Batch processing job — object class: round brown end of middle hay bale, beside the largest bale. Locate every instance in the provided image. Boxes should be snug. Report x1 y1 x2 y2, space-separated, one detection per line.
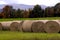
31 21 44 33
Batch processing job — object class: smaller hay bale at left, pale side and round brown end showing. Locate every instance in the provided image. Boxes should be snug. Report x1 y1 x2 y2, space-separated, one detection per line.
0 21 22 31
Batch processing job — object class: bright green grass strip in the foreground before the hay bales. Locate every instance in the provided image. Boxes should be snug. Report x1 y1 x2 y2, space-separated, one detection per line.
0 31 60 40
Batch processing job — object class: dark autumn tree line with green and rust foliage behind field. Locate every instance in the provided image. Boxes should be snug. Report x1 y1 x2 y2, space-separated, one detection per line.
0 3 60 18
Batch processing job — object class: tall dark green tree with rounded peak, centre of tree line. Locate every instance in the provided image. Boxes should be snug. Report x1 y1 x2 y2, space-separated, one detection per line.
29 5 43 18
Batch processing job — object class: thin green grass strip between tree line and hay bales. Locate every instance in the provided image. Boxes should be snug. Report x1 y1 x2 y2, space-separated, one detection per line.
0 17 60 21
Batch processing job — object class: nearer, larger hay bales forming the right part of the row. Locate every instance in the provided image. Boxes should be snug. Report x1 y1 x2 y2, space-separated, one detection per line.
22 20 60 33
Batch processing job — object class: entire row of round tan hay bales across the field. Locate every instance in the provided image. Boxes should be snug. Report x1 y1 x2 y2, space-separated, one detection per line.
0 20 60 33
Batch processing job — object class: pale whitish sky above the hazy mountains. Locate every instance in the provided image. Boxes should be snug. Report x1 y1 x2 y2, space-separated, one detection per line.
0 0 60 6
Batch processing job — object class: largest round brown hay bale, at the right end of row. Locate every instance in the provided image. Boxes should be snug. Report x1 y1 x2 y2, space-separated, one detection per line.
44 20 60 33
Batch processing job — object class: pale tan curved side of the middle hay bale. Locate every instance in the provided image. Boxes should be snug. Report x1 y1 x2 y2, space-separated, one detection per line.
22 20 33 32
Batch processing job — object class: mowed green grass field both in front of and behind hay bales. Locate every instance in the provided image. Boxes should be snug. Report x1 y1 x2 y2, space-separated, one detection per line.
0 17 60 40
